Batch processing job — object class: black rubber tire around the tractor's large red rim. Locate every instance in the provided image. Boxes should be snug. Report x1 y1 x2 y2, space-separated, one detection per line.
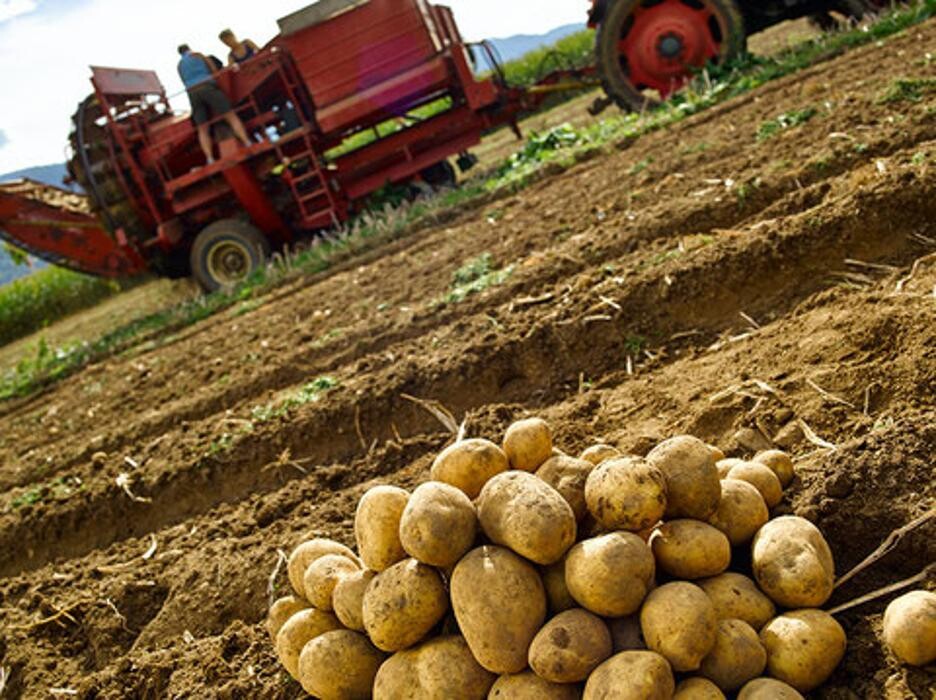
595 0 747 112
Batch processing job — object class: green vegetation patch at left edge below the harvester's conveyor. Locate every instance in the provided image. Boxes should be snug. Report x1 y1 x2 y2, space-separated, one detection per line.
0 264 121 345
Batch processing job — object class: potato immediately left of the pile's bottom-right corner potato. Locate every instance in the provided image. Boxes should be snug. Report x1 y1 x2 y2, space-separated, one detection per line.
699 620 767 690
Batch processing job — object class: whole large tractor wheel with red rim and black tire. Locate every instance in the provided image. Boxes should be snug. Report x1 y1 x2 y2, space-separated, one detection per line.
596 0 745 111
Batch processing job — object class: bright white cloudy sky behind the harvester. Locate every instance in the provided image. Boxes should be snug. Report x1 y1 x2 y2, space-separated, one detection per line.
0 0 590 173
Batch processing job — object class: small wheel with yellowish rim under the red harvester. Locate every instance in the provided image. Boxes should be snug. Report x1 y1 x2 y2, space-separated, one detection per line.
189 219 270 292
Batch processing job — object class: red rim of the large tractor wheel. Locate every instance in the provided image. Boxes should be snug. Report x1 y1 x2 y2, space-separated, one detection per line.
618 0 726 99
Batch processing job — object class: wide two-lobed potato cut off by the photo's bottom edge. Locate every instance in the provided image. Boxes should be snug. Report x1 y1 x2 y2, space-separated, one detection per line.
374 635 496 700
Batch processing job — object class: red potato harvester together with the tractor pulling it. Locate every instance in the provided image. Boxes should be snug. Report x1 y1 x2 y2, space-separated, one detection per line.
0 0 887 289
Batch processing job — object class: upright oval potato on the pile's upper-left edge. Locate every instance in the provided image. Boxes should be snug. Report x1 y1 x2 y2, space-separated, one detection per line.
354 486 409 572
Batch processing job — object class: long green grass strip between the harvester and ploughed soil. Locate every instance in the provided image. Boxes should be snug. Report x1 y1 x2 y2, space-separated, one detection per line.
0 0 936 400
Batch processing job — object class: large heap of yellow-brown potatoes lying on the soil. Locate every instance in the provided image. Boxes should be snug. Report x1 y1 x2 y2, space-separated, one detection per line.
267 418 932 700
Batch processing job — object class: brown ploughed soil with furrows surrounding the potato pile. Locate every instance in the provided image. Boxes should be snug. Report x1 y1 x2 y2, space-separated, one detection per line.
0 16 936 699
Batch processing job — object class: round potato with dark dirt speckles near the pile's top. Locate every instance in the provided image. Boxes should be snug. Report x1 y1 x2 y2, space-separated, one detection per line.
585 457 666 532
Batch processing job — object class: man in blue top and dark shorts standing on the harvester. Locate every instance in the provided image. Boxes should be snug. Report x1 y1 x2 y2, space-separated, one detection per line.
179 44 251 165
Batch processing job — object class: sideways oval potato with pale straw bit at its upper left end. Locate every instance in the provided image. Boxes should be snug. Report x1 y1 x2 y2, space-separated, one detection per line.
650 520 731 579
